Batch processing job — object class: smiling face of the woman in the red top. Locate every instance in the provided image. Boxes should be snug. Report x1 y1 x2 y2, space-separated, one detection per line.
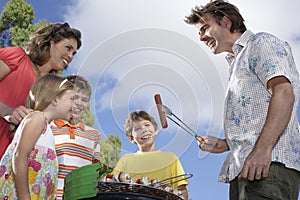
48 38 77 71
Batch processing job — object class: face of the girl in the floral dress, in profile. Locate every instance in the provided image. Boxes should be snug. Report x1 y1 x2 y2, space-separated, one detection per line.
56 90 74 121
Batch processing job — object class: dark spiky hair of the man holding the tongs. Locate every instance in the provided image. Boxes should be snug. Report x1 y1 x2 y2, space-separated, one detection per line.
184 0 247 33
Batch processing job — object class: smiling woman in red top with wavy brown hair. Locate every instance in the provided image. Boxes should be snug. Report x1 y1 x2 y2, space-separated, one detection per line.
0 23 81 158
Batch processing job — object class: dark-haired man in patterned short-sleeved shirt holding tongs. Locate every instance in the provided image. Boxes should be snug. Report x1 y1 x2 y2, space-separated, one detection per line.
185 0 300 200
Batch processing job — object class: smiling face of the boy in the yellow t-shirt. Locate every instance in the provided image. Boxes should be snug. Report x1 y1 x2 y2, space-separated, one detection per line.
132 120 157 150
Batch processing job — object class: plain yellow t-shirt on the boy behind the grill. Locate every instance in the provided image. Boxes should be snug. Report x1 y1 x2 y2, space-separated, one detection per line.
112 151 188 188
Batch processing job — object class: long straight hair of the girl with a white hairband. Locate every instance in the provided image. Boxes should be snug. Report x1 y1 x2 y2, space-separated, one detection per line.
26 74 73 111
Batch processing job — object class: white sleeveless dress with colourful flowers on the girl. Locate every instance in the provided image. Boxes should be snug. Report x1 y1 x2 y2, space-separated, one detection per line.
0 113 58 200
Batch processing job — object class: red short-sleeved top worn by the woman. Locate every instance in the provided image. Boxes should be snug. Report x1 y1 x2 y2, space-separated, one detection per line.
0 47 37 158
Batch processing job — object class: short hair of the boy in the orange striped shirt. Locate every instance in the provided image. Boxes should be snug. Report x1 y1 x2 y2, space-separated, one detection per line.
65 75 92 98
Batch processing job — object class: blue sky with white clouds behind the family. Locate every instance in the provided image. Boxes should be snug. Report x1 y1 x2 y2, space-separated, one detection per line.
0 0 300 200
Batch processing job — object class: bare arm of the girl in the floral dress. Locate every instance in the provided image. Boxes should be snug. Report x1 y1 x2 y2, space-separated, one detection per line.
13 112 45 200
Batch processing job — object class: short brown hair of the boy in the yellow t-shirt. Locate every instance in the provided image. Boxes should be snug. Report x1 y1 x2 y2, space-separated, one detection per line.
124 110 157 136
